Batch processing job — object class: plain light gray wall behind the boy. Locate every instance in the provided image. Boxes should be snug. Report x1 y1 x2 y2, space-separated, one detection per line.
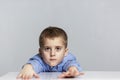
0 0 120 75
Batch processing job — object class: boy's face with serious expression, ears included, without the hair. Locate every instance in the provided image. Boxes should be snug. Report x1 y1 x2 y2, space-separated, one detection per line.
40 37 68 66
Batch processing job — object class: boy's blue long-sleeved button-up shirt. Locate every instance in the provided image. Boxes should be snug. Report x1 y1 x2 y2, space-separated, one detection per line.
27 53 82 73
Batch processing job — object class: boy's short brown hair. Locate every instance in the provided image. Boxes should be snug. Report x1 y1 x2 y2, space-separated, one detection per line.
39 26 68 48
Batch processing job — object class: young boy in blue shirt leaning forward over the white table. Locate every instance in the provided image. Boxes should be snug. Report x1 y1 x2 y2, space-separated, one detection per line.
17 26 82 79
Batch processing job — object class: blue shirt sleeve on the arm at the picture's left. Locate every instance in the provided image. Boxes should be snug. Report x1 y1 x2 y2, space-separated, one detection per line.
27 54 43 73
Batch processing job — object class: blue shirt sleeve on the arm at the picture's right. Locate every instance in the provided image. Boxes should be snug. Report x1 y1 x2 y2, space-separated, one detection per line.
63 54 82 71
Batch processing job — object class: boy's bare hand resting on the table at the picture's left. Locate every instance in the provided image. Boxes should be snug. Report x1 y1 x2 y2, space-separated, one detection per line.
17 64 39 80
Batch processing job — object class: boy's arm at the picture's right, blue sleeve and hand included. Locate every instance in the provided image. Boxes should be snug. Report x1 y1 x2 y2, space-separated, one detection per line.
59 56 83 78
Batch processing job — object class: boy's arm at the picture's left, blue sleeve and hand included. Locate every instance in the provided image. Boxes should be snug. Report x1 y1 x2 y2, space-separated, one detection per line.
17 54 43 79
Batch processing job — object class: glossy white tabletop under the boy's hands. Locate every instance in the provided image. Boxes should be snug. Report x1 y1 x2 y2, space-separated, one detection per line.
0 71 120 80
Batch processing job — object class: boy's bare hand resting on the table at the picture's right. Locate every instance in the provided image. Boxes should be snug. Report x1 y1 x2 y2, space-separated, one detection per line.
58 66 84 78
